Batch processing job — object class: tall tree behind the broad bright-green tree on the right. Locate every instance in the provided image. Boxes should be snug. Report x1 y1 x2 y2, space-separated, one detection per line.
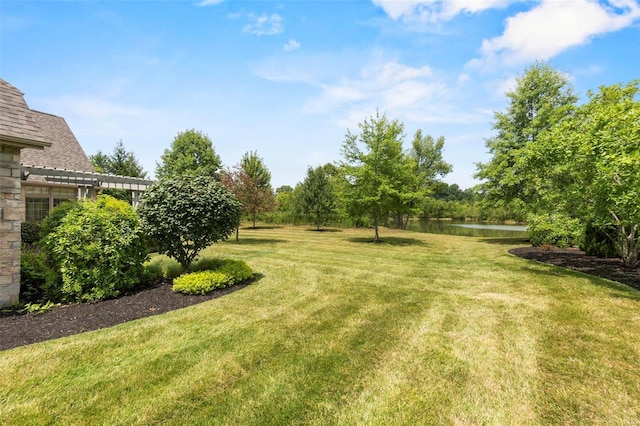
476 62 577 208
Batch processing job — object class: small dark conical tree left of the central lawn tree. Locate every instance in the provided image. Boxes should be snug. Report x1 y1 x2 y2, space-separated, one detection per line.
298 166 336 230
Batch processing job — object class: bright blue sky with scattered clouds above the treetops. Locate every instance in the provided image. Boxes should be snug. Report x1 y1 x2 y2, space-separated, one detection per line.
0 0 640 188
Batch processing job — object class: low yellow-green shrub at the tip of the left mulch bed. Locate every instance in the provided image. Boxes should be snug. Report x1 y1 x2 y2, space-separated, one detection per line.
173 259 253 294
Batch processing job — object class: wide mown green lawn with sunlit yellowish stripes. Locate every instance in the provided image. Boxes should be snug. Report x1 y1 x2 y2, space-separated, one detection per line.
0 228 640 425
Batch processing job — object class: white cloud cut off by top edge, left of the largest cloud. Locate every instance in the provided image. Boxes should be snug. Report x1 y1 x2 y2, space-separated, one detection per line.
372 0 525 23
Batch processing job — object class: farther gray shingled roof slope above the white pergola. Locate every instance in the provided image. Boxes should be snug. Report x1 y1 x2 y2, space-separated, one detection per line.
20 111 95 172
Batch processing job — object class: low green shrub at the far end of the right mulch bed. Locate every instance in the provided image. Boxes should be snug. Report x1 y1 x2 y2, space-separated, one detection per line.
527 215 584 247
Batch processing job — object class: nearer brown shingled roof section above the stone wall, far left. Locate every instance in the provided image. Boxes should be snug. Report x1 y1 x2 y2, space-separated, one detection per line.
0 78 47 146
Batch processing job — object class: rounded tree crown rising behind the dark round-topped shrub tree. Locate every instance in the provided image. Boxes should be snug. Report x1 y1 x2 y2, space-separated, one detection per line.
156 130 221 179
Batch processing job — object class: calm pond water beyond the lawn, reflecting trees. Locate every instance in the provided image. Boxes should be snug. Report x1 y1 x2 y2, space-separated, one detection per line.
407 220 527 238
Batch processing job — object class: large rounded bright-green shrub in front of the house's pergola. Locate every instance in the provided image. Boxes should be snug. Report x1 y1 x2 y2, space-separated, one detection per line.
44 195 146 300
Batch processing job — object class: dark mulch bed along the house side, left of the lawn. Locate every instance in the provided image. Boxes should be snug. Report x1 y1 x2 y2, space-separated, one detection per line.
0 282 249 351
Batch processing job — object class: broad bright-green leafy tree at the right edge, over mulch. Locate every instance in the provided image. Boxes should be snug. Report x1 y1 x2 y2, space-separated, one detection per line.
517 80 640 265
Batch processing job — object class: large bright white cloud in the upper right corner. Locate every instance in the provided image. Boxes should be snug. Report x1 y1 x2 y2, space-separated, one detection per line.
467 0 640 68
